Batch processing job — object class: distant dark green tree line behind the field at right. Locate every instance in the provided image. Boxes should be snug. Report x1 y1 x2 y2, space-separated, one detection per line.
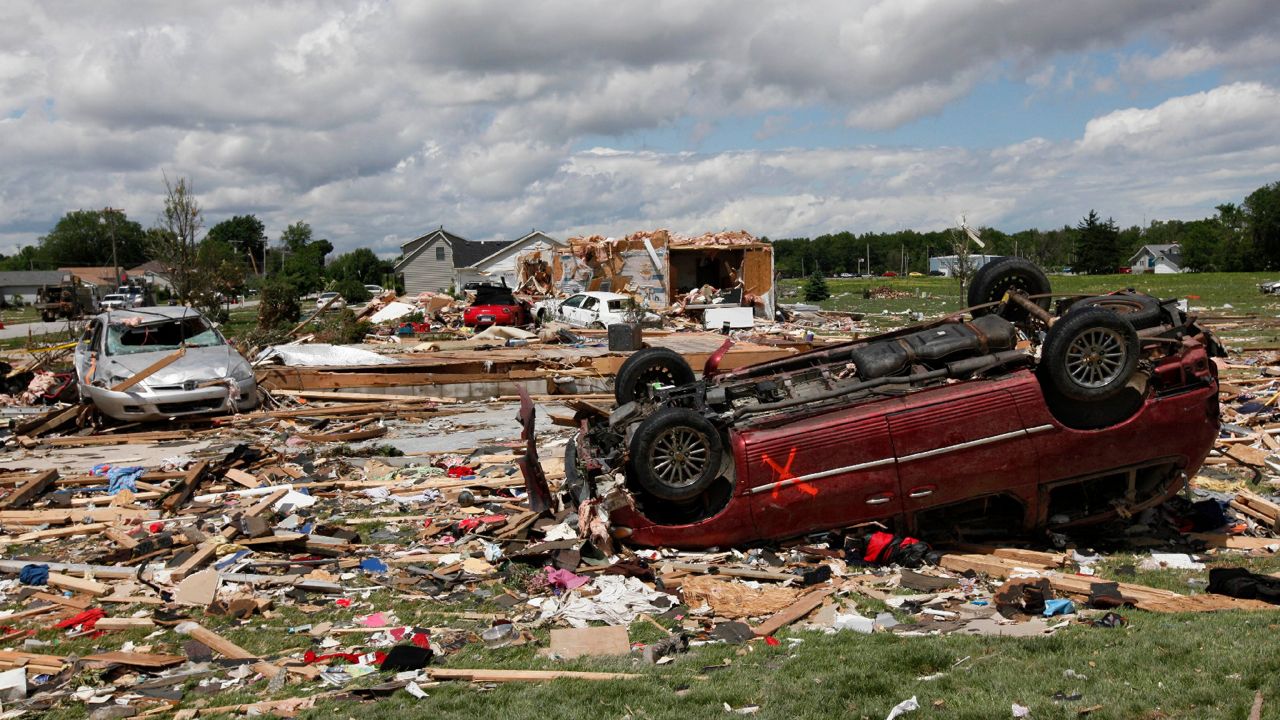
773 182 1280 278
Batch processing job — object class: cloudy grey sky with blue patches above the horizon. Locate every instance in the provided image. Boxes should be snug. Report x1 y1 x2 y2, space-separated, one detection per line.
0 0 1280 255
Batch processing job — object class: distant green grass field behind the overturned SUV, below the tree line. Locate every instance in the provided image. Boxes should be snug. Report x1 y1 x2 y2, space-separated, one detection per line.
782 273 1280 343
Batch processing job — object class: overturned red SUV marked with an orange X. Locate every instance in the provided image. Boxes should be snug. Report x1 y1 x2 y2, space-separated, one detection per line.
521 258 1221 548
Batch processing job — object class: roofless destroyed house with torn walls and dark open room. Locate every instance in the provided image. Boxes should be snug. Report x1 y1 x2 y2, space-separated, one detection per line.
517 229 774 318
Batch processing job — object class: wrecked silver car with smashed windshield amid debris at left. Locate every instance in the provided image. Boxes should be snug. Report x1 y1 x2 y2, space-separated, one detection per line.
76 307 259 420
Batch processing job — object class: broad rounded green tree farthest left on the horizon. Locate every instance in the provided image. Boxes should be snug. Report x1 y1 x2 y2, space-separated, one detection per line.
38 210 147 268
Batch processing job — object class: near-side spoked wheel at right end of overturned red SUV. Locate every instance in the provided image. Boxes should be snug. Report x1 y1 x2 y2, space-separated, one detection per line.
1041 307 1139 402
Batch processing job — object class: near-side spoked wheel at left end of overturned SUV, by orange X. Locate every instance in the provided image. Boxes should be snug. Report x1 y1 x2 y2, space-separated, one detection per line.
630 407 723 501
